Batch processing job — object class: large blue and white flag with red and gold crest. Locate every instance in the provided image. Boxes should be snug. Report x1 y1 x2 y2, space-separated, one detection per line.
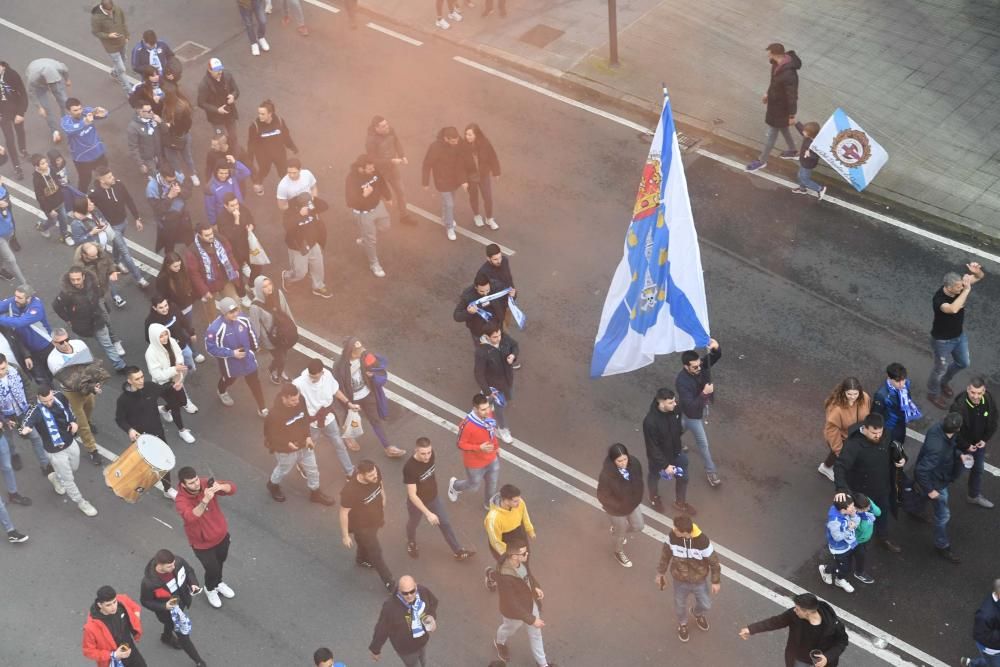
590 90 709 377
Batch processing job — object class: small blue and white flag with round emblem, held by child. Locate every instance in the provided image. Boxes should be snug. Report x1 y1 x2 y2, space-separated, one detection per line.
810 109 889 192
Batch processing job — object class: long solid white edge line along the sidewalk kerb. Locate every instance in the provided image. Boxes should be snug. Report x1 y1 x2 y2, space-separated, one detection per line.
453 56 1000 264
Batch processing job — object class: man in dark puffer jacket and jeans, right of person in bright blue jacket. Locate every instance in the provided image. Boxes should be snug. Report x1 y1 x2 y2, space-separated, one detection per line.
52 266 125 373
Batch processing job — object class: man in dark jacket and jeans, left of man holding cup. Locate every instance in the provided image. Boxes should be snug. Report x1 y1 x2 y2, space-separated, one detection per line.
916 412 972 565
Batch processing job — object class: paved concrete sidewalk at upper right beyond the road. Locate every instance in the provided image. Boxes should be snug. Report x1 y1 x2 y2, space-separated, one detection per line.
362 0 1000 239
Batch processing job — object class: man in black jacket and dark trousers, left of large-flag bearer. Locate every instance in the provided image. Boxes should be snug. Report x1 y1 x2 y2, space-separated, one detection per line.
642 387 697 516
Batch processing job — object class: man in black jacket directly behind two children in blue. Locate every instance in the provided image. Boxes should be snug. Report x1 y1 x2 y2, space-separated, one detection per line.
833 413 906 554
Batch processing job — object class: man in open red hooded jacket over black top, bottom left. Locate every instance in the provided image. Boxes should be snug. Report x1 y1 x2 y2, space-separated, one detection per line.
83 586 146 667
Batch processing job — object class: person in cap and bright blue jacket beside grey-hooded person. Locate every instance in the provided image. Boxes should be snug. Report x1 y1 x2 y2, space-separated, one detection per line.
205 296 268 417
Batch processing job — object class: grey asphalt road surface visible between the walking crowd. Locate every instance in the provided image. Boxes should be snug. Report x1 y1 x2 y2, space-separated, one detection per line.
0 0 1000 667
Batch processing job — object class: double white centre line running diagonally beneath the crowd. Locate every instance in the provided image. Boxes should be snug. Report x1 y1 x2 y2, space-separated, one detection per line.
8 189 947 667
